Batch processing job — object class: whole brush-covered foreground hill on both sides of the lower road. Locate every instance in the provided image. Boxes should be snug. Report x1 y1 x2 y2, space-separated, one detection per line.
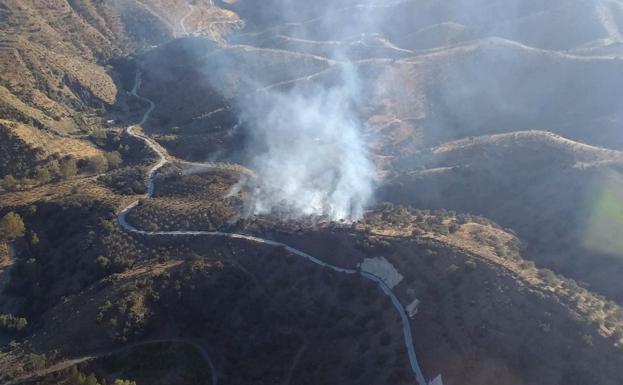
0 201 621 385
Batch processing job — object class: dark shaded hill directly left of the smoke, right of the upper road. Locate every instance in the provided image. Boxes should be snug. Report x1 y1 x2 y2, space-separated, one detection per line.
138 38 333 161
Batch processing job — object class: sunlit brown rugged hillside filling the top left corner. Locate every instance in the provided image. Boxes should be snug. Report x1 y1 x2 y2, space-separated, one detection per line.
0 0 237 177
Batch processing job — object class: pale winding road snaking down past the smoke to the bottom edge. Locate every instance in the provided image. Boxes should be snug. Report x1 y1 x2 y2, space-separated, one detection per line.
118 74 427 385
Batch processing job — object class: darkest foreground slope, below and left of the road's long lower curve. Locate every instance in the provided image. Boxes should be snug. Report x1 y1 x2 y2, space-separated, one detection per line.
2 239 410 384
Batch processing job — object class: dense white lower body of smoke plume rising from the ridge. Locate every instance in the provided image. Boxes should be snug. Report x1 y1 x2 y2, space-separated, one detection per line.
240 66 375 220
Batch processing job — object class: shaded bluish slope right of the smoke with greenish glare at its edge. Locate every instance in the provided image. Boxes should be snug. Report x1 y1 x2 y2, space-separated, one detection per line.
381 132 623 302
